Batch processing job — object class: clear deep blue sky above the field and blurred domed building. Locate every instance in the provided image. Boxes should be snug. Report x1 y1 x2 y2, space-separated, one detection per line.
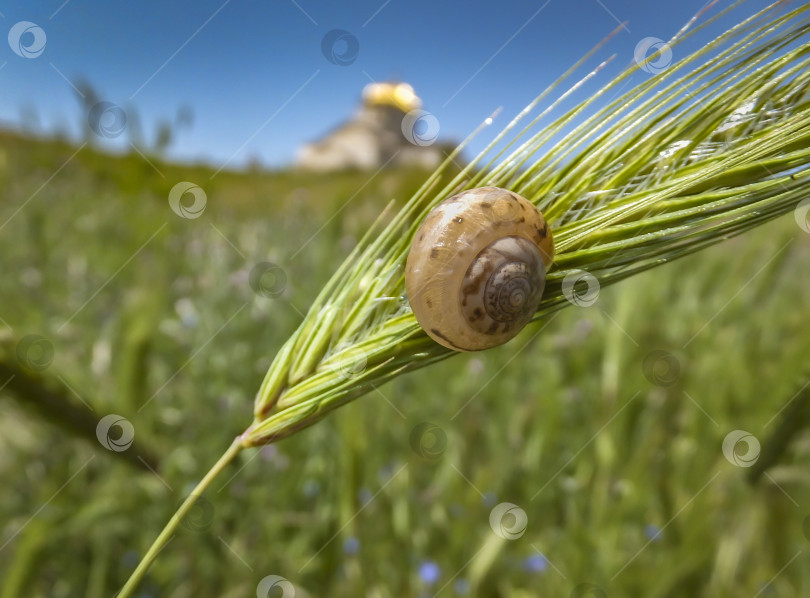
0 0 766 167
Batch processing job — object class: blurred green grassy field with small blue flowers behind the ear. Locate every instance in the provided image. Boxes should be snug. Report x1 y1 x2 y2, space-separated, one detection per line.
0 133 810 598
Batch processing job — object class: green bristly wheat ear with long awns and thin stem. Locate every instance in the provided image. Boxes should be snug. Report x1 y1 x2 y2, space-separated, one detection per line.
119 2 810 598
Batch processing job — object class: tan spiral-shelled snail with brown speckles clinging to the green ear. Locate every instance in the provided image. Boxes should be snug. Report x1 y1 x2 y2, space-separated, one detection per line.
405 187 554 351
